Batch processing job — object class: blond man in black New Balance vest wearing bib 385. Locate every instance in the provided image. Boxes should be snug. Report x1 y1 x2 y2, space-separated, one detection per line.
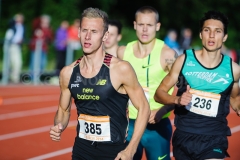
50 8 150 160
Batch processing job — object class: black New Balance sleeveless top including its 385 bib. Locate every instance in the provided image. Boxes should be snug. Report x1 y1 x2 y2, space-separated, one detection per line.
68 53 129 144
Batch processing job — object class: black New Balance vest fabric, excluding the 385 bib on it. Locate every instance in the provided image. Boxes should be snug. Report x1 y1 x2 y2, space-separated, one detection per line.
68 54 129 144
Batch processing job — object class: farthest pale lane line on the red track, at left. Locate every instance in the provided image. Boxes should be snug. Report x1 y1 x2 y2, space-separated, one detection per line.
1 94 59 105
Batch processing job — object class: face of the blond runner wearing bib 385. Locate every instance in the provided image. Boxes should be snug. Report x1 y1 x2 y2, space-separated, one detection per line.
79 17 107 54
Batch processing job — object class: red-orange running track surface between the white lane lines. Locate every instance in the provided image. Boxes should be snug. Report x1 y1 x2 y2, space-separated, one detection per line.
0 86 240 160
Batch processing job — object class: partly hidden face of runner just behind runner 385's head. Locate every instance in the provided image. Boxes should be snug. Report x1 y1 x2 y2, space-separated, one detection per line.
104 25 120 48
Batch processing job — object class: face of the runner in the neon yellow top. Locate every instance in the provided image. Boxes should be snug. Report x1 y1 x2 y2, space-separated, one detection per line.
134 13 160 43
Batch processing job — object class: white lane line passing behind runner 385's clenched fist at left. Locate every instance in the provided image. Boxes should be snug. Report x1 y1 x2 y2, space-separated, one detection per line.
0 121 77 141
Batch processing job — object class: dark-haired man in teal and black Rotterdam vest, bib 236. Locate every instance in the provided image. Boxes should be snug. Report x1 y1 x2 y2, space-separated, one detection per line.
155 11 240 160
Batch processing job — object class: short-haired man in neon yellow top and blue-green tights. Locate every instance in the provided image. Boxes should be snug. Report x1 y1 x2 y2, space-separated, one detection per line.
118 6 177 160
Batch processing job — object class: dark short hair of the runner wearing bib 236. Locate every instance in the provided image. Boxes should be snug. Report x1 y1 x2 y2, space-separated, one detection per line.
199 10 229 34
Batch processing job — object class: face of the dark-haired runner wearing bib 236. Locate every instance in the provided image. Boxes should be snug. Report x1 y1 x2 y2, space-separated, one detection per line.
200 19 227 52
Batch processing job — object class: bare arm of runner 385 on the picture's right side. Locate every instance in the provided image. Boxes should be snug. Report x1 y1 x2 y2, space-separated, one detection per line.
118 61 150 156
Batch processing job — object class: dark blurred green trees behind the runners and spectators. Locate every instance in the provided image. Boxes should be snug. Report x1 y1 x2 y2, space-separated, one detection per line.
0 0 240 70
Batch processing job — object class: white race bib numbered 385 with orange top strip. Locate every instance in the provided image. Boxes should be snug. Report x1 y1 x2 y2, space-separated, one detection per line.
78 114 111 142
